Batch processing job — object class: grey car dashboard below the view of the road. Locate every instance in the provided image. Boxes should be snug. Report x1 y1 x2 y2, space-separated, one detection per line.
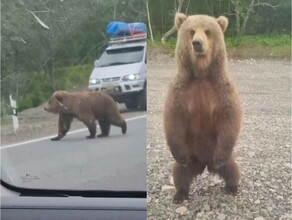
1 167 147 220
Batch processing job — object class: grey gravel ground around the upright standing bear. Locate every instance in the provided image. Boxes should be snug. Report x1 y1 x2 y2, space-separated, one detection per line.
147 54 292 220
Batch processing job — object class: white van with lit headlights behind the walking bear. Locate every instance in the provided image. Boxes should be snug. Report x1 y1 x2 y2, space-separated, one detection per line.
88 34 147 110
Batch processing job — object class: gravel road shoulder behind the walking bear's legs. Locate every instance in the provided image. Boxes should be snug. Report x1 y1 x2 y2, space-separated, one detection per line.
1 103 146 146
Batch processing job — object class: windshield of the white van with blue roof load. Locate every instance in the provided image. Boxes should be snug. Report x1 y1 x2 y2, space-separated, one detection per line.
97 46 144 67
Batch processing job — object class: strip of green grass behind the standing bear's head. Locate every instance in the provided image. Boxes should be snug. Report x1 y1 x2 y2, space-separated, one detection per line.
148 34 291 60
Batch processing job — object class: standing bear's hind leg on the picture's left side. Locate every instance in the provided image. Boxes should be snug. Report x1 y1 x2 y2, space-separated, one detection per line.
172 156 205 203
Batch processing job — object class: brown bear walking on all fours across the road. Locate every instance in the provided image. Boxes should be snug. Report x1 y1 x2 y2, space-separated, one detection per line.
44 91 127 141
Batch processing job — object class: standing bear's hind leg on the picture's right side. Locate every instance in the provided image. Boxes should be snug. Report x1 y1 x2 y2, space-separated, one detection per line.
208 158 240 195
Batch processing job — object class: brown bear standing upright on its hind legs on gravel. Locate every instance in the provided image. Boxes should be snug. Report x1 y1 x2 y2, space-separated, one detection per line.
164 13 242 203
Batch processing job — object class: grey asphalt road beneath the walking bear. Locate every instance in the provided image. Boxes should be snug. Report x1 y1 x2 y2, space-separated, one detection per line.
1 116 147 190
